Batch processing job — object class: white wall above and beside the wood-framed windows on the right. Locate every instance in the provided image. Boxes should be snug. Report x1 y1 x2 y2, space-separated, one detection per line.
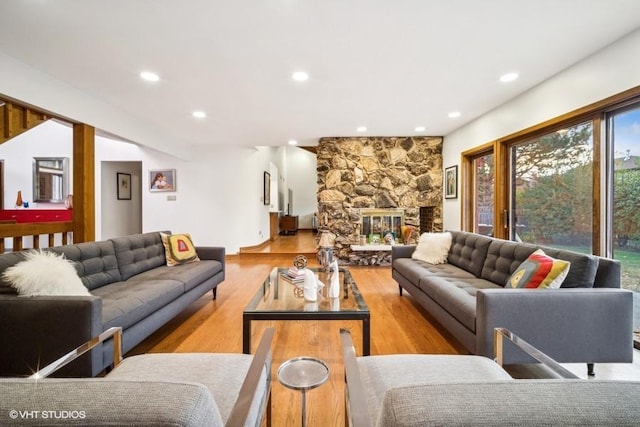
442 31 640 230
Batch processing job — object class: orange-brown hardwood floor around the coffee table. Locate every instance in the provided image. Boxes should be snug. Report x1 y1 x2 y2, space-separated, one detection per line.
127 231 640 427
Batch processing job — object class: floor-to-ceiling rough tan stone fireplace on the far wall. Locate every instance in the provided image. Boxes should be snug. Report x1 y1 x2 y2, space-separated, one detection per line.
317 137 442 265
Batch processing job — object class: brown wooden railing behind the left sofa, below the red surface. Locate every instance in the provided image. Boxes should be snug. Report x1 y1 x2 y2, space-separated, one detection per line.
0 221 73 253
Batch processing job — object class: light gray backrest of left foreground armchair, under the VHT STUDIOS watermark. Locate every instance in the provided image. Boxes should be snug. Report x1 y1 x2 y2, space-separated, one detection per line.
0 378 224 427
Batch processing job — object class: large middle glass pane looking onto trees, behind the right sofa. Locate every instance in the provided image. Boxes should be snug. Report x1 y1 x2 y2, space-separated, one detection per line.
509 122 593 254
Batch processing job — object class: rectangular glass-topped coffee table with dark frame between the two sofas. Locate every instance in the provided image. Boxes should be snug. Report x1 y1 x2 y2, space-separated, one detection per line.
242 267 371 356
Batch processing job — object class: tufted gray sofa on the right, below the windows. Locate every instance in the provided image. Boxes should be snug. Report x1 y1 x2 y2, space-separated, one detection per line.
391 231 633 369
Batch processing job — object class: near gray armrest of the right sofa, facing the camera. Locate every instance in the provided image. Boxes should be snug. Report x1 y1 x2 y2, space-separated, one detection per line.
475 288 633 363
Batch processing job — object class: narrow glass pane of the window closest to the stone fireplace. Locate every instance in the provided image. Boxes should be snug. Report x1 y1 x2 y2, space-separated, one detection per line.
472 153 495 236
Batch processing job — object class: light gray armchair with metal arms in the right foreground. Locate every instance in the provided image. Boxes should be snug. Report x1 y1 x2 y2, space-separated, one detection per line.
340 330 640 427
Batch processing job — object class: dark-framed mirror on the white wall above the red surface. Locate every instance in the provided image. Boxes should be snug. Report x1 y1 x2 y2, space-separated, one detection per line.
33 157 69 203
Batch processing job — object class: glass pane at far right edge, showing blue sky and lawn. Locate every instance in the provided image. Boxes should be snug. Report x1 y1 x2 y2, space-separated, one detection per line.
607 103 640 341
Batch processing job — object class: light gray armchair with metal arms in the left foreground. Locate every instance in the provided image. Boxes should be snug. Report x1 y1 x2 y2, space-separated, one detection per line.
0 328 274 427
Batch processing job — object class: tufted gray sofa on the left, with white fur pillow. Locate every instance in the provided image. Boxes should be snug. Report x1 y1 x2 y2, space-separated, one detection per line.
0 232 225 376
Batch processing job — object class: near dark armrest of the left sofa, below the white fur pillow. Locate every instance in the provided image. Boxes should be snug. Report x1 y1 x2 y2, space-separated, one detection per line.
0 295 103 377
